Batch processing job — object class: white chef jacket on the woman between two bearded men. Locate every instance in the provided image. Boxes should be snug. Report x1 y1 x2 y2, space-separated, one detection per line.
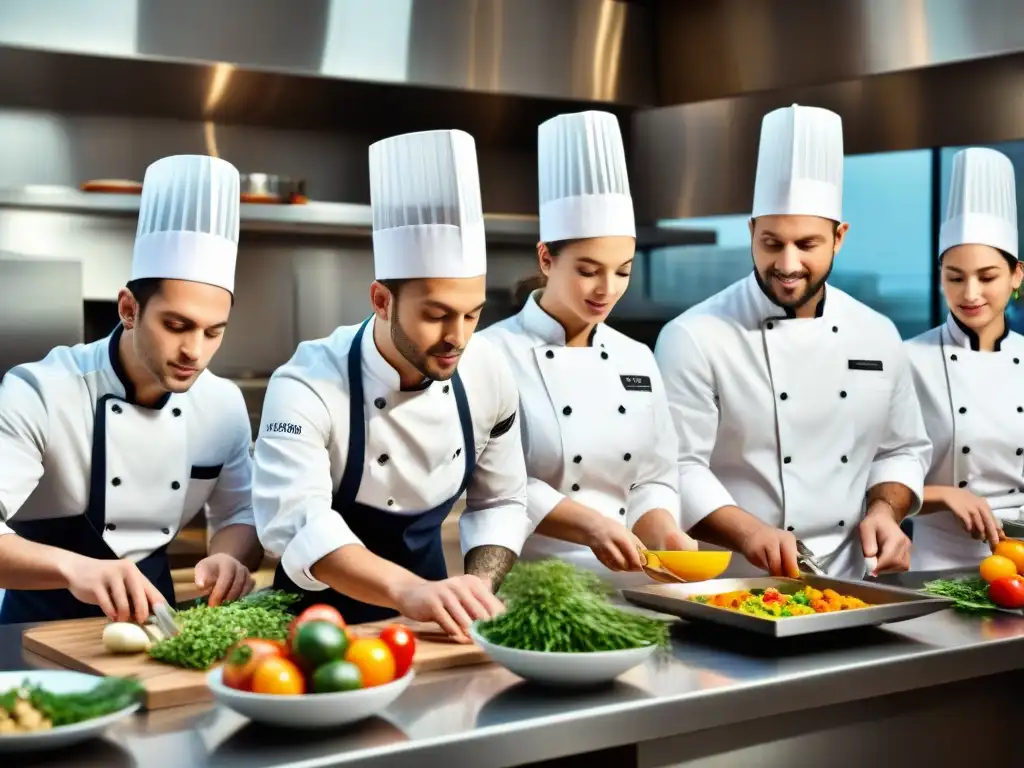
480 294 679 587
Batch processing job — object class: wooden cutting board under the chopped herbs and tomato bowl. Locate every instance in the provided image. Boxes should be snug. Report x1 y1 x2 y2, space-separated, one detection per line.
22 618 488 710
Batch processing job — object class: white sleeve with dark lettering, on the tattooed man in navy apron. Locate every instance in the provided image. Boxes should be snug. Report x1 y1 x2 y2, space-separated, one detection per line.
253 375 360 591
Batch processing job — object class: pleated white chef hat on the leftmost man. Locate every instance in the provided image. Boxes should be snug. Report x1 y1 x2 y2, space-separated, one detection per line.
131 155 241 293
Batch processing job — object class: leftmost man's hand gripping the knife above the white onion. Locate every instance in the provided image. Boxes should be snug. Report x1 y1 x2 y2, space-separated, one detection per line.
68 557 167 624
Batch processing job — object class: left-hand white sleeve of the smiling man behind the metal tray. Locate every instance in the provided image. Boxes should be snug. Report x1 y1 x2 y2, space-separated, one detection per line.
654 323 736 530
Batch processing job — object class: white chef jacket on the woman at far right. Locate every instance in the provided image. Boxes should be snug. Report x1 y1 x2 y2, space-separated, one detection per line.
906 313 1024 570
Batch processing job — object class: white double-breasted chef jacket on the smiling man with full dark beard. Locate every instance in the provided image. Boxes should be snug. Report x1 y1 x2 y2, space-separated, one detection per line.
654 273 931 579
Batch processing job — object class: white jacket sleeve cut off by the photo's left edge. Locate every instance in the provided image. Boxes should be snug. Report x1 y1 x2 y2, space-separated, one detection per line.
0 369 49 536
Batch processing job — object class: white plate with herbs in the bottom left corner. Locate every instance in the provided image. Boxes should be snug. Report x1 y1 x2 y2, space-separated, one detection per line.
0 670 141 753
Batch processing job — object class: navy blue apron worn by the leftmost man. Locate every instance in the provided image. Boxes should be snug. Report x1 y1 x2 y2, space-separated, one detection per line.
0 326 175 625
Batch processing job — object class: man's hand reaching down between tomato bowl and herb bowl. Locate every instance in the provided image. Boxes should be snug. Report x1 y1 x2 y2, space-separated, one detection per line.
395 573 505 643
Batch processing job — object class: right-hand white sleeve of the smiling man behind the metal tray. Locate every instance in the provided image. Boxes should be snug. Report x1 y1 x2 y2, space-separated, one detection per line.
867 347 933 515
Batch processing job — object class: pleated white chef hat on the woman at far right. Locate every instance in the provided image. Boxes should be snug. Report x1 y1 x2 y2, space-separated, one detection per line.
939 146 1018 259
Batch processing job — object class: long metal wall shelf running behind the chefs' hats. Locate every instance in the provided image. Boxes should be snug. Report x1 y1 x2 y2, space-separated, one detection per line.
0 185 715 248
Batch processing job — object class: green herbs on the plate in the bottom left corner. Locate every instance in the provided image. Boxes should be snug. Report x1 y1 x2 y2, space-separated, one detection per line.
0 677 145 728
